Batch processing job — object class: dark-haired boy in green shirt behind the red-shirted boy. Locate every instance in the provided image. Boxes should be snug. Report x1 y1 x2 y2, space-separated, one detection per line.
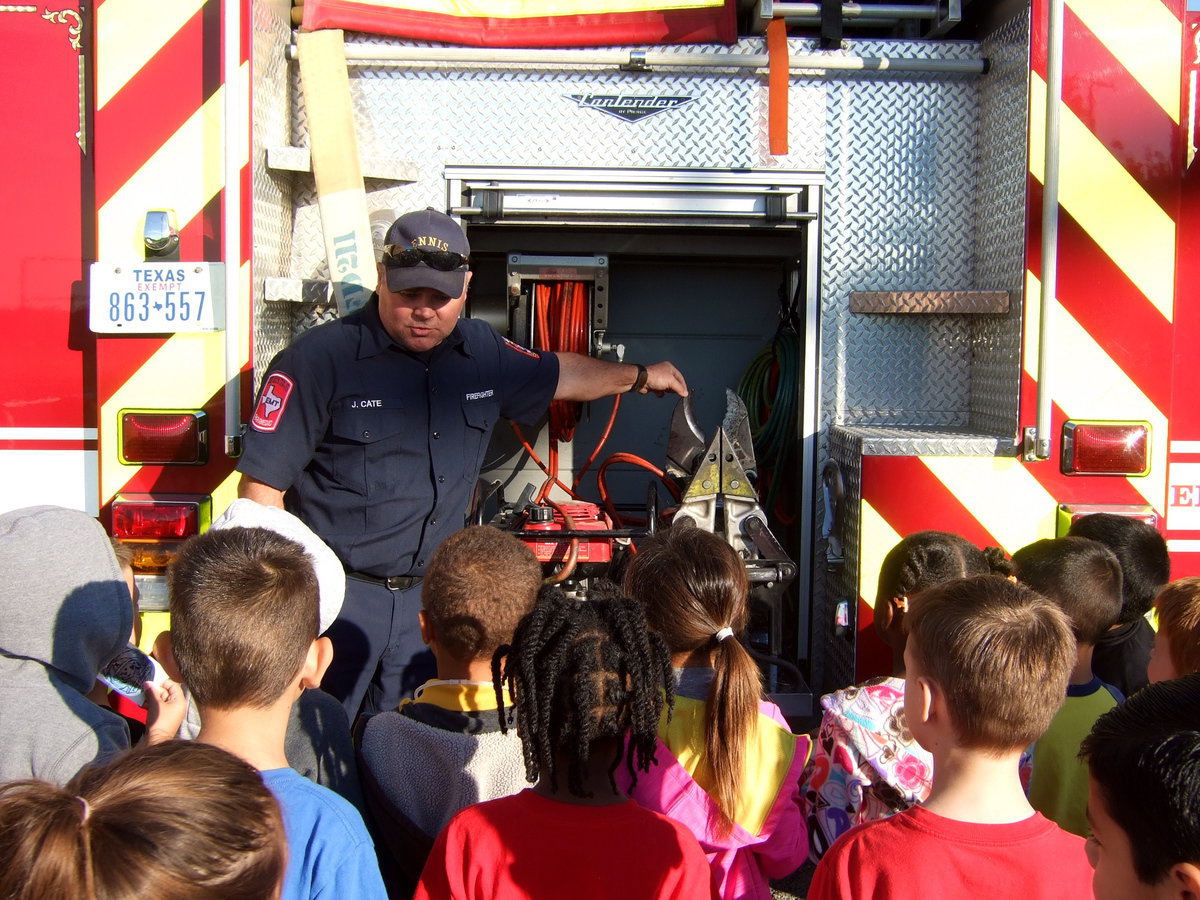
1013 536 1124 836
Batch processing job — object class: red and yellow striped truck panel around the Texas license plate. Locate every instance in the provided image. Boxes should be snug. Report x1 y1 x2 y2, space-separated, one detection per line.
95 0 251 525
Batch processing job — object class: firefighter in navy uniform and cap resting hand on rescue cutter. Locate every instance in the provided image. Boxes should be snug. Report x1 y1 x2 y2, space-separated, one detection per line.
238 209 688 720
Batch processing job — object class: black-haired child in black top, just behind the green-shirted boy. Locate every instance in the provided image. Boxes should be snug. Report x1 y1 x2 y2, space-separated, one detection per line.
1068 512 1171 697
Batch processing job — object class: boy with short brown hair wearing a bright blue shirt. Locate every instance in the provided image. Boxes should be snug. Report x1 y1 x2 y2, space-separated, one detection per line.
168 528 385 900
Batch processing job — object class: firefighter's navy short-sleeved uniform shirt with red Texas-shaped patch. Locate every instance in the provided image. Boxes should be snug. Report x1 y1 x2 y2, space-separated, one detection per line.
238 296 558 577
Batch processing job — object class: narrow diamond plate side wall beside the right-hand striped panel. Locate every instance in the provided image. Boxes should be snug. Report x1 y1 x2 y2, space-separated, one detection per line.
970 10 1030 436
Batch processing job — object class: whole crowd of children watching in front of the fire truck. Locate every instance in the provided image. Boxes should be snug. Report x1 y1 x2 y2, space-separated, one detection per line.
0 500 1200 900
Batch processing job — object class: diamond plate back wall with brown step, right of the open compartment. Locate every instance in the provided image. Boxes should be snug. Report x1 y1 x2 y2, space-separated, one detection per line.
821 42 979 434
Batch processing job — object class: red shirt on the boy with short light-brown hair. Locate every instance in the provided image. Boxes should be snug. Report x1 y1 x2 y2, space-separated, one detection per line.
808 806 1092 900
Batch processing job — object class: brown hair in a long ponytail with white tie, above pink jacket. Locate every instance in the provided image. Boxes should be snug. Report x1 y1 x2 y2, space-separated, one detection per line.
625 524 762 829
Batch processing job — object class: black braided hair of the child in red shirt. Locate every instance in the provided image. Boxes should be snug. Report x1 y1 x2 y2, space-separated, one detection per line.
492 584 674 797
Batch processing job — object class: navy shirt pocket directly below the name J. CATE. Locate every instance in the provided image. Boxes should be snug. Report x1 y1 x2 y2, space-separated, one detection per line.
329 400 404 497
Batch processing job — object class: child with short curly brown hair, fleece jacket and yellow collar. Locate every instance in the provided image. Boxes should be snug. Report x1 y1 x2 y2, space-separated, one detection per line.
360 526 542 889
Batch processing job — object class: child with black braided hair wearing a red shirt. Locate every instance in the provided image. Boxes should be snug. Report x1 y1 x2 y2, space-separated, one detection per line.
414 588 714 900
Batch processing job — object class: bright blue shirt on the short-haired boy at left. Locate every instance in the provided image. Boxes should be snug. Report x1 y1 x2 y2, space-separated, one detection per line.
263 769 388 900
